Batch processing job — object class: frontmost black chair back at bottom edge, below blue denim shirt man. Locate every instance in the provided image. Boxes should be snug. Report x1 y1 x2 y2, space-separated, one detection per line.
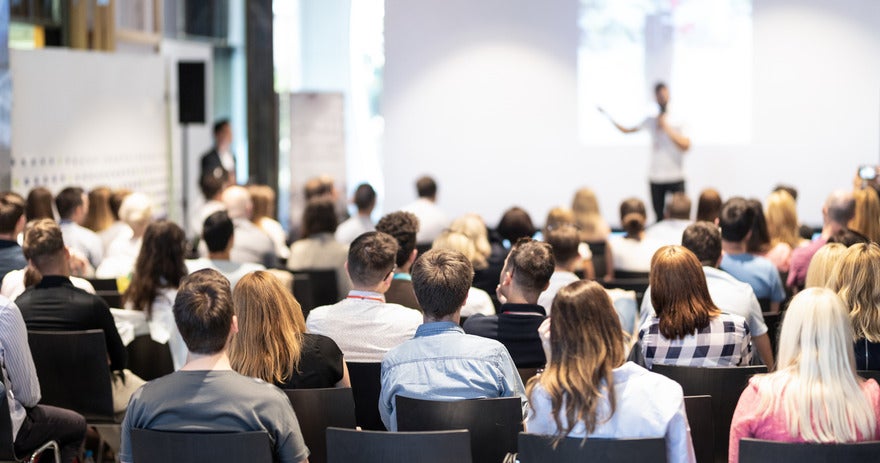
326 428 470 463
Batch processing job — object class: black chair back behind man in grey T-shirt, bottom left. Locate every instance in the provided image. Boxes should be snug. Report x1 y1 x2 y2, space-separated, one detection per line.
131 429 272 463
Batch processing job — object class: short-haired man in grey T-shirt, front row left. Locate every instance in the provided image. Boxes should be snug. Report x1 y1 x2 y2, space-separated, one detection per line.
119 269 309 463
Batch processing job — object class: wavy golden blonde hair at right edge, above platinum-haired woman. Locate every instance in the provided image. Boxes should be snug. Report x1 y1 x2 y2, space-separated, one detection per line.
827 243 880 342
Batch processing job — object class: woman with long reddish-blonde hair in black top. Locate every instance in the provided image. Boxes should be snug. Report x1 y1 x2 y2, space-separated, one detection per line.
229 270 351 389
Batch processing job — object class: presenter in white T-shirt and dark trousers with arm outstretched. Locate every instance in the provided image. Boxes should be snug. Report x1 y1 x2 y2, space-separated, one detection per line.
599 82 691 225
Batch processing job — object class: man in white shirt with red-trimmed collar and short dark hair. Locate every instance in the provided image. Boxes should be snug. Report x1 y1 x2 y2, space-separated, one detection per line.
306 232 422 363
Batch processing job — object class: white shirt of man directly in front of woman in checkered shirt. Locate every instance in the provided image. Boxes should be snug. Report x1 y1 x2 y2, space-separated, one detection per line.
641 266 767 337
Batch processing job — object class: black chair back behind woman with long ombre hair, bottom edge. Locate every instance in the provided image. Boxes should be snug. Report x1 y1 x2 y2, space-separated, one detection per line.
517 432 666 463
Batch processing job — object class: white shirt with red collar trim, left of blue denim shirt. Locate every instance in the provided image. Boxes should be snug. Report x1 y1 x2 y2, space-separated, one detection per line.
306 291 423 363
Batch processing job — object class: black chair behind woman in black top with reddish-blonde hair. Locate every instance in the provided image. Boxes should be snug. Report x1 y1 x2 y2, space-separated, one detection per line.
284 387 357 463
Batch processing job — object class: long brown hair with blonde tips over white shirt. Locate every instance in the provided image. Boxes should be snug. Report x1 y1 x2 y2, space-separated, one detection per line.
526 280 626 443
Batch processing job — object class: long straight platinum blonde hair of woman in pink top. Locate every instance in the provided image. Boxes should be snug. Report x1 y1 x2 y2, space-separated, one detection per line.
760 288 877 443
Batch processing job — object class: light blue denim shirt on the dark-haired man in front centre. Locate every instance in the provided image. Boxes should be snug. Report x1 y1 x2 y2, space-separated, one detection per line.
379 322 528 431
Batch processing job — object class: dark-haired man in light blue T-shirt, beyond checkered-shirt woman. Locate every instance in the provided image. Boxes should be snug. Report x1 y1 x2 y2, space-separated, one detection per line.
719 198 785 312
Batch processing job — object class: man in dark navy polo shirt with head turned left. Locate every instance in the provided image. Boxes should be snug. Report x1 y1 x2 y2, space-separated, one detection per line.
464 238 556 368
